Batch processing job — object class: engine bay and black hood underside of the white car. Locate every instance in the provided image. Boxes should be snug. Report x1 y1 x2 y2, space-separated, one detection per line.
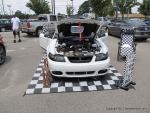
56 24 101 57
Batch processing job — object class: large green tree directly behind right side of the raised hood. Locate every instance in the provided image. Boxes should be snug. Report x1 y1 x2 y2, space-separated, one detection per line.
89 0 112 16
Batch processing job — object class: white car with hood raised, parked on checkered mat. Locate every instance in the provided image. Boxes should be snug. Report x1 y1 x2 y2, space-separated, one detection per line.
39 19 110 78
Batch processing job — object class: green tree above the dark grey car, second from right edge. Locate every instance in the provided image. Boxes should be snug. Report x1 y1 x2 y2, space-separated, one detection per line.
113 0 139 19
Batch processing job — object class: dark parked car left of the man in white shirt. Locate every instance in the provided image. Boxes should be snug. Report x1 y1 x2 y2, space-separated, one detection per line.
0 19 12 32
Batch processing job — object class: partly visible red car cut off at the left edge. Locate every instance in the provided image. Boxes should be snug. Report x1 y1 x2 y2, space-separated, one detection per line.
0 35 6 65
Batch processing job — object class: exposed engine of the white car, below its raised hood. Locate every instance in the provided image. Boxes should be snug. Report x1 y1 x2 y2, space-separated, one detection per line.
56 36 101 57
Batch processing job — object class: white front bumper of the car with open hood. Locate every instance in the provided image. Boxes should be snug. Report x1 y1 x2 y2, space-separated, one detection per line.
48 58 110 78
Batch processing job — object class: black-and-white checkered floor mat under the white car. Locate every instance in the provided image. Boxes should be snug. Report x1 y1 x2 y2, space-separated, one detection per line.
25 59 122 95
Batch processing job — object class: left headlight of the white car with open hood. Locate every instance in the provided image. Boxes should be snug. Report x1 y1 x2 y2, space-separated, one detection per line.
48 53 65 62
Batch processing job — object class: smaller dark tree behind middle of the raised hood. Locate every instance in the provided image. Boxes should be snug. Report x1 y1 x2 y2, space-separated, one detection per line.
78 1 90 15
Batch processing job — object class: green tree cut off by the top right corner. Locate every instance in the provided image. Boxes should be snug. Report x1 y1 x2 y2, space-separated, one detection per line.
138 0 150 17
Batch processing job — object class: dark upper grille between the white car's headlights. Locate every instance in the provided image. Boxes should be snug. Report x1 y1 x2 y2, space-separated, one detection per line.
68 56 93 63
